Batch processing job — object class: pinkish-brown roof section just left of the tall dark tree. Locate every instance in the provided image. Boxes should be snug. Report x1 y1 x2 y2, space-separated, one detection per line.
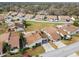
8 32 20 50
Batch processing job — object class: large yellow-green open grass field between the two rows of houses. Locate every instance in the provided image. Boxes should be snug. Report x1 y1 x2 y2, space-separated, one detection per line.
26 21 62 31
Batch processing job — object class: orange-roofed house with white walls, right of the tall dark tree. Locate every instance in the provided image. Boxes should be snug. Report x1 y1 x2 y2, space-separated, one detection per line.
24 31 47 47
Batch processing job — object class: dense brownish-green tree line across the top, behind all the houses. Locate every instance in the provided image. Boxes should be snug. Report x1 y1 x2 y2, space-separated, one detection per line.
0 2 79 16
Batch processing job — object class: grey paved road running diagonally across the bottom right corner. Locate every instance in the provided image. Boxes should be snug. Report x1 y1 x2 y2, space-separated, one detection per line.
42 42 79 57
